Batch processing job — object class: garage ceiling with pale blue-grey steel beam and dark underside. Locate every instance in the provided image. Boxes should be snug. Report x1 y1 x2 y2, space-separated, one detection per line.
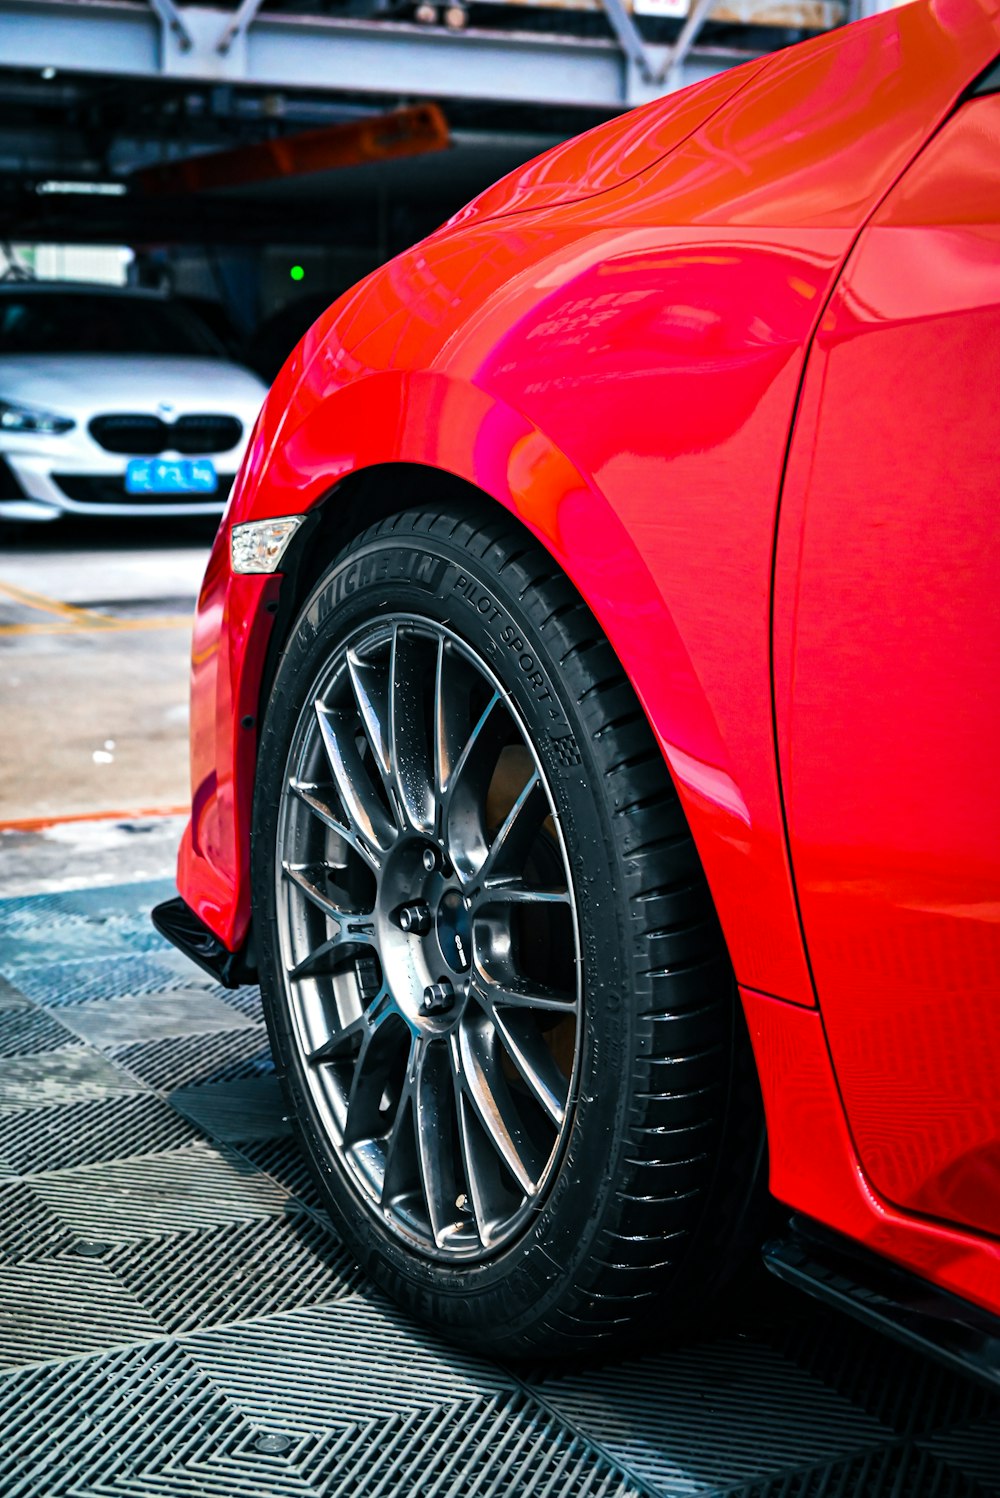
0 0 826 247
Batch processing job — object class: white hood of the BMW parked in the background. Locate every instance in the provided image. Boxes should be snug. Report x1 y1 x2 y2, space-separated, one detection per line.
0 354 268 419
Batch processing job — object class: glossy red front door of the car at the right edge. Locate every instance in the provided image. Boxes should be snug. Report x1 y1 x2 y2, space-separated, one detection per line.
774 85 1000 1233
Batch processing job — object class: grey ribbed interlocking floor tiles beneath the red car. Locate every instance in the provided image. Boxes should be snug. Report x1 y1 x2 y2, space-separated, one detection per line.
0 882 1000 1498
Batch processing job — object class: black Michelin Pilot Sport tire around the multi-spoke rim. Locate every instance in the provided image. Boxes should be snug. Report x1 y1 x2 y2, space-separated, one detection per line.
251 502 765 1356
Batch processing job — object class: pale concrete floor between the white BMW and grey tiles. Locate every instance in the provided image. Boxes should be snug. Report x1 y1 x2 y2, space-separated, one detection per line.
0 520 211 838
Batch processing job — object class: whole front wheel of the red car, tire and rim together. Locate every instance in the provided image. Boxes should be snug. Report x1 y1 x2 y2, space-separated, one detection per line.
253 506 762 1354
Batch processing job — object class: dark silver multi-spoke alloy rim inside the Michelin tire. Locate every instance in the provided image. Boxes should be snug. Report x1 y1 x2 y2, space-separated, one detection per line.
275 614 582 1261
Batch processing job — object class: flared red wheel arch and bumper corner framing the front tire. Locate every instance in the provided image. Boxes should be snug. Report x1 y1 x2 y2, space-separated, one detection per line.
178 372 810 1002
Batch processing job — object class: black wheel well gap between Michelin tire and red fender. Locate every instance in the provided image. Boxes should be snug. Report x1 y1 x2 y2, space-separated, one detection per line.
257 463 497 722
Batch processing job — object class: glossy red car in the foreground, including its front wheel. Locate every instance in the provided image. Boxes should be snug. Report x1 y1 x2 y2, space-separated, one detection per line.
156 0 1000 1378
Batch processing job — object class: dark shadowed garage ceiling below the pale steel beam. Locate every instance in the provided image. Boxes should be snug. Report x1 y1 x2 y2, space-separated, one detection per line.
0 70 577 244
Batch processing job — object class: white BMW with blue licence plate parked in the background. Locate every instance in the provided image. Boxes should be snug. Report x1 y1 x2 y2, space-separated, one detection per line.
0 282 266 521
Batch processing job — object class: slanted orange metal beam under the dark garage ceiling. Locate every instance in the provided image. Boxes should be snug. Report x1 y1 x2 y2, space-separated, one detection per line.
135 103 451 196
